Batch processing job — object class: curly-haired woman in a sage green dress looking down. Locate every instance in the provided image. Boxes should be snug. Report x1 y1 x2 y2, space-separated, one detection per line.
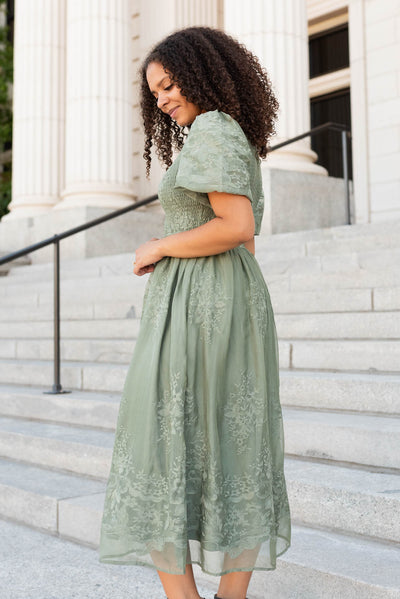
100 27 290 599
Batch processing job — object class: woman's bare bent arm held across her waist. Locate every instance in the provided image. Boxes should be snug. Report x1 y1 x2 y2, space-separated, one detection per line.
134 191 254 275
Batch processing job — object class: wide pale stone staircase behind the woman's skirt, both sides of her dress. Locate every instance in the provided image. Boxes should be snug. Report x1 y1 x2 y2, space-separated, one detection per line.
0 222 400 599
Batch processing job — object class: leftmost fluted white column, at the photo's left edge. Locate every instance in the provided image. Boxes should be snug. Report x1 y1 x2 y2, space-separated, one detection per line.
2 0 65 221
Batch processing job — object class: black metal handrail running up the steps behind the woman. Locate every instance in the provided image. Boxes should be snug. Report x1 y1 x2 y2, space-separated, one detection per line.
0 122 350 394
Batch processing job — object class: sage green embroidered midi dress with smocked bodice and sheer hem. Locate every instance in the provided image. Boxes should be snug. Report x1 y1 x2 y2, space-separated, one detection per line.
99 110 290 575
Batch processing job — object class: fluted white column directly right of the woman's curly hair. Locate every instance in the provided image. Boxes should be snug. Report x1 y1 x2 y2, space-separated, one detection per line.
224 0 326 174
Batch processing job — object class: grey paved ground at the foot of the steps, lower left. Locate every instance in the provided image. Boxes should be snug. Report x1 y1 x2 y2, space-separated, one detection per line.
0 520 214 599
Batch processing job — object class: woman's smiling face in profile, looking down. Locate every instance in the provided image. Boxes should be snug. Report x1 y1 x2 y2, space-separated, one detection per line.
146 62 205 127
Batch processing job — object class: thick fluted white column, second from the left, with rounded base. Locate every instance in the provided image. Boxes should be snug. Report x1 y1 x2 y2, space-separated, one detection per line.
57 0 134 209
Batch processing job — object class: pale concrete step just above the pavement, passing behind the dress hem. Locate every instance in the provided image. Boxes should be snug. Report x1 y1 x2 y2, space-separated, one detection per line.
0 458 400 545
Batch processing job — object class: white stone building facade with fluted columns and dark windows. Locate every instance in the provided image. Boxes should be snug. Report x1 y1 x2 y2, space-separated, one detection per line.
0 0 400 258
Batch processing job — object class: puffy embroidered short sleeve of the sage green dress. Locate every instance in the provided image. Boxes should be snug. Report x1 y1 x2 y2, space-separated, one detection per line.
175 110 254 202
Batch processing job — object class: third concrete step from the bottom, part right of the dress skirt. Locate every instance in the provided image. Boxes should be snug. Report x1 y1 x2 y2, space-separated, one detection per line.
283 408 400 470
